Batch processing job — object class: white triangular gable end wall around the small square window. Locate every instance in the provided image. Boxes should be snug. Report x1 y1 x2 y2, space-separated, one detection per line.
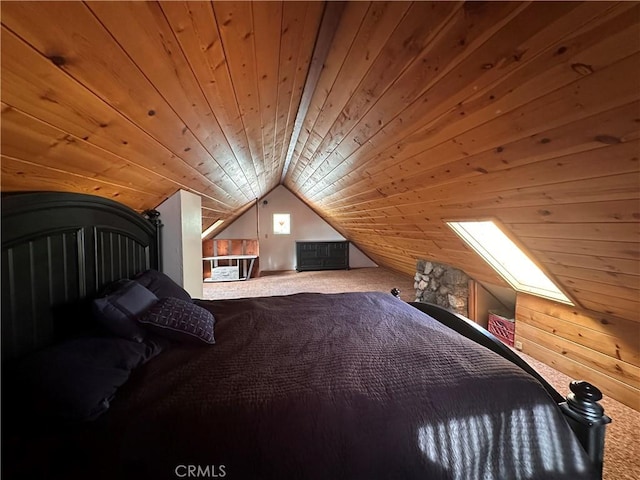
215 185 377 271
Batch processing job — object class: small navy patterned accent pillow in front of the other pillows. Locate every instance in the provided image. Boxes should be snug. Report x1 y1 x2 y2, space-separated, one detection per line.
138 297 216 345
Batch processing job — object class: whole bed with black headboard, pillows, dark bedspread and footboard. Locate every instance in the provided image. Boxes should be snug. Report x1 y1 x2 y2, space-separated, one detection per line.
2 192 609 480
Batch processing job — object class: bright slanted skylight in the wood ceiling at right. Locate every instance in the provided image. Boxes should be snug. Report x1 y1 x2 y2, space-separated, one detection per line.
447 221 573 305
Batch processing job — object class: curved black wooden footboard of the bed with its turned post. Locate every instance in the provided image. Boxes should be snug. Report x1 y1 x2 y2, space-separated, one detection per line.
402 296 611 478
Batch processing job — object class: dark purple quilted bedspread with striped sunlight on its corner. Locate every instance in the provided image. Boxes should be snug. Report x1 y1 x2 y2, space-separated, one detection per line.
13 293 594 480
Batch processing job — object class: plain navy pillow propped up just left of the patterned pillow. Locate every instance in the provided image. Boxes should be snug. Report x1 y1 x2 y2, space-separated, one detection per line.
93 280 158 342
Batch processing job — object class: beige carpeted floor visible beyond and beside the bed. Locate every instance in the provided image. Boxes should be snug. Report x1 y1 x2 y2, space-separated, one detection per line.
203 268 640 480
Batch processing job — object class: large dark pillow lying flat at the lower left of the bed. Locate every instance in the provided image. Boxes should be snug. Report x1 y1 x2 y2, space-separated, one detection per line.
9 337 163 421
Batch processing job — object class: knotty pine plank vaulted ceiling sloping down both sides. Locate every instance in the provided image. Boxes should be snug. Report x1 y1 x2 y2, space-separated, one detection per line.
1 2 640 320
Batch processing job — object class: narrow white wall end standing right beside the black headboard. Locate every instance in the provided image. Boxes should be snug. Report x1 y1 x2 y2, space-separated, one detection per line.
156 190 202 298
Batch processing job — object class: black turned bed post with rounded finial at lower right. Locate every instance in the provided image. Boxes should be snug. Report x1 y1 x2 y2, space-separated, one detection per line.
560 380 611 478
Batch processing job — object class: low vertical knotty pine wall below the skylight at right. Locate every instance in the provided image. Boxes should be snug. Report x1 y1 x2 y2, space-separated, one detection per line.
516 294 640 409
